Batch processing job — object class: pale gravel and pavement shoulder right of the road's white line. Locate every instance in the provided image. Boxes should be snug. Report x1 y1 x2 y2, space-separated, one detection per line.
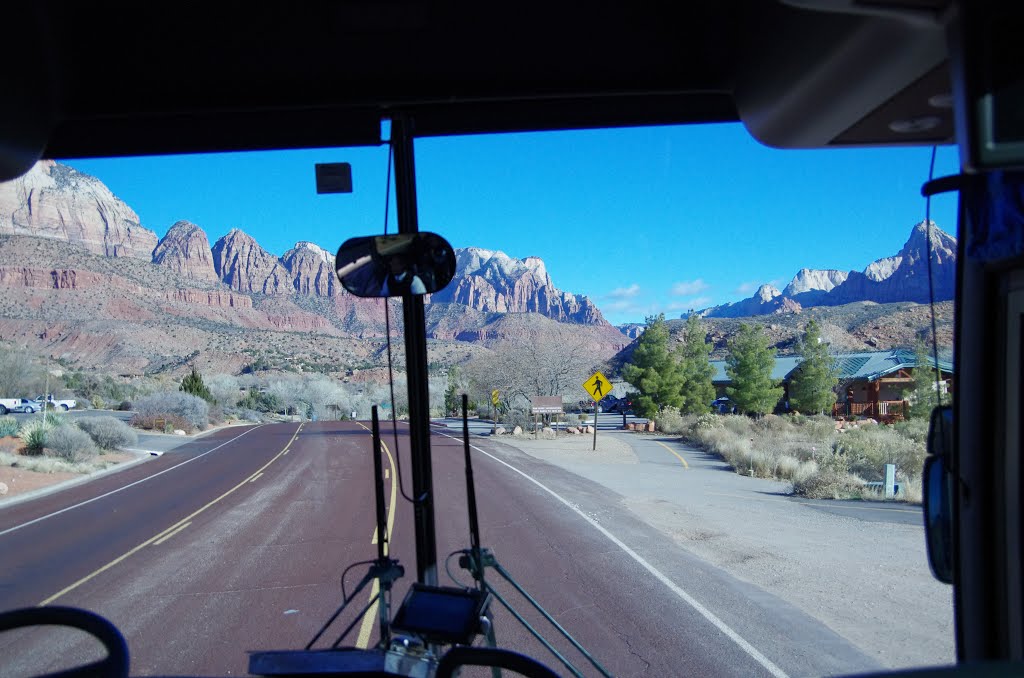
491 434 955 668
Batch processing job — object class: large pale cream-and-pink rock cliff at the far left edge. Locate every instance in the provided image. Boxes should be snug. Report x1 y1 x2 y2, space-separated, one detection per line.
0 160 157 261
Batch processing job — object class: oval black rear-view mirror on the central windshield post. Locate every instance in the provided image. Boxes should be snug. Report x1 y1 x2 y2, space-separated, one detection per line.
335 232 455 297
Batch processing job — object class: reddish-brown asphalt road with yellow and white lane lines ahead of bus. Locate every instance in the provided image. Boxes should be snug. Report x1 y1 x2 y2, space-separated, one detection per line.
0 422 878 676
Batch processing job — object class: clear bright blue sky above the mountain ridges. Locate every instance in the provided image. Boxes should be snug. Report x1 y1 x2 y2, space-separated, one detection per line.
68 124 958 324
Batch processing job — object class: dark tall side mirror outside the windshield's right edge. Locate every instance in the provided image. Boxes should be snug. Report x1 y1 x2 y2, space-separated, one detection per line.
922 406 953 584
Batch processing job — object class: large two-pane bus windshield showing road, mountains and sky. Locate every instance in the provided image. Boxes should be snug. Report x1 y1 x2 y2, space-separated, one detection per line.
0 125 957 676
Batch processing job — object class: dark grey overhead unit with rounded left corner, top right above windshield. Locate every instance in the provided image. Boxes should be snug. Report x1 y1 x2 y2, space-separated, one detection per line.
734 7 954 149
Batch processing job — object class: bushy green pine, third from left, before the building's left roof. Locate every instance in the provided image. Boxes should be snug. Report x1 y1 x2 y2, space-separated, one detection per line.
725 323 782 415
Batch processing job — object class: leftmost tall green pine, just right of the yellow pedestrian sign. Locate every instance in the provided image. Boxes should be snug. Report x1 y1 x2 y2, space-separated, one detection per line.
623 313 683 417
